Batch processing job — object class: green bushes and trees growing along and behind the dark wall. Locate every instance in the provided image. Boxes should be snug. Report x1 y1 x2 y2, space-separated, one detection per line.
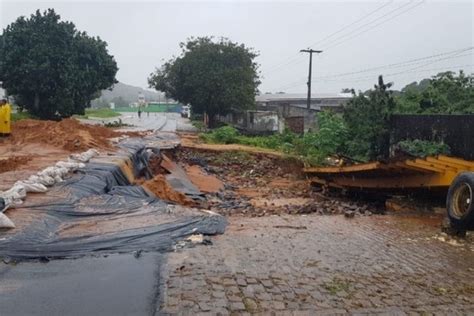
201 72 474 165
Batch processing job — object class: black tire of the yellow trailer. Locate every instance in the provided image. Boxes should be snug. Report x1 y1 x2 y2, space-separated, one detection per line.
446 172 474 230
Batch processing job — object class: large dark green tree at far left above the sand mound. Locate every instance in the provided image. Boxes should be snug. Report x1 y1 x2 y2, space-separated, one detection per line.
0 9 118 119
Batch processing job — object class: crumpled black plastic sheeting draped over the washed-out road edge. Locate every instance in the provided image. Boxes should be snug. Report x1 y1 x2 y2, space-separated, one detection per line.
0 136 227 259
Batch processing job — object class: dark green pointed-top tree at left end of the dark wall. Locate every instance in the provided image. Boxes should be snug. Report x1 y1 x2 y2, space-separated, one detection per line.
343 76 395 160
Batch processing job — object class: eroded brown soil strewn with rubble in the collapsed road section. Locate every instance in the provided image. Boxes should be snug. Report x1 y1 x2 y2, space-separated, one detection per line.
175 148 384 216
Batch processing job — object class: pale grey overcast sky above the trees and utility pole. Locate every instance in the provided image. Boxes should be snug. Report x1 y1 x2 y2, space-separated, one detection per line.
0 0 474 93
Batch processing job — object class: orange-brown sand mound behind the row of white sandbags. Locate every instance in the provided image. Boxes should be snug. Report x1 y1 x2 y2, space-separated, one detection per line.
11 119 121 151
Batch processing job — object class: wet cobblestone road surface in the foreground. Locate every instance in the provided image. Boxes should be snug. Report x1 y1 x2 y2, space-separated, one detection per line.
160 215 474 315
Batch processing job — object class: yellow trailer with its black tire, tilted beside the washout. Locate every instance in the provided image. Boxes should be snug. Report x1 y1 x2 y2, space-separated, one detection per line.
304 155 474 231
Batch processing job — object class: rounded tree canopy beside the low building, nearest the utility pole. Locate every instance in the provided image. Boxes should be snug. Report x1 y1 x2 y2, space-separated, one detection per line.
148 37 260 124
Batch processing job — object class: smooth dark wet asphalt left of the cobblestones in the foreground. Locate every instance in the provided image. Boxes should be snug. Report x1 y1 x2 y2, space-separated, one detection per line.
0 254 162 316
